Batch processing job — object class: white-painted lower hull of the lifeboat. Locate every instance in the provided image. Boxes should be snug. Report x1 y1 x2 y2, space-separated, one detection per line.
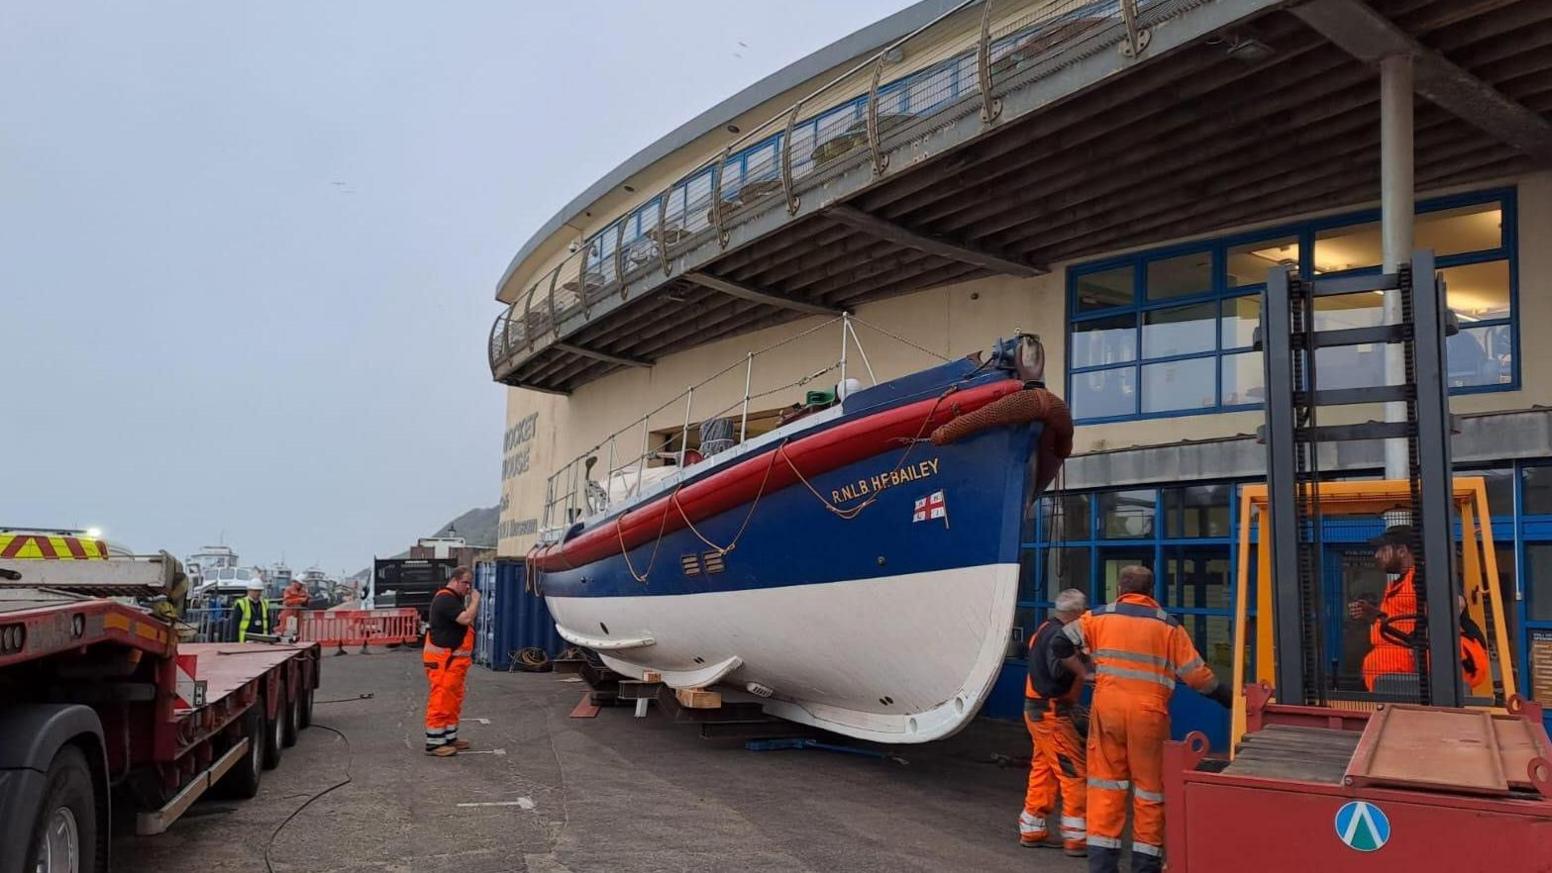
546 564 1018 743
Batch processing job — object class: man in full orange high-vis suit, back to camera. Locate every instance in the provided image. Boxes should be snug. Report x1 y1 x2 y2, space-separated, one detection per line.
1052 565 1232 873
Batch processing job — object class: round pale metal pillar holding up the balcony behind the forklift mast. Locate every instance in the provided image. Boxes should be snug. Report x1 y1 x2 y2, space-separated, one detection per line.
1380 54 1415 475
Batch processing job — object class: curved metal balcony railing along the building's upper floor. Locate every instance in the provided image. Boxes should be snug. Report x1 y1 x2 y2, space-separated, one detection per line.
489 0 1167 374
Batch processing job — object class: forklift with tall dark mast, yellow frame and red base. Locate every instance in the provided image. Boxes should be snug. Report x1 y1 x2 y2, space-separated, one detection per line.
1164 252 1552 873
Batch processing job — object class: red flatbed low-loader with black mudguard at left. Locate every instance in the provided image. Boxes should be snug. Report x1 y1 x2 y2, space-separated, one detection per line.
0 553 320 873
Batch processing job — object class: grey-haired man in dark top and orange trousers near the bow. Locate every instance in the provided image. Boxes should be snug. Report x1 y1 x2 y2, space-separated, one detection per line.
1018 589 1088 857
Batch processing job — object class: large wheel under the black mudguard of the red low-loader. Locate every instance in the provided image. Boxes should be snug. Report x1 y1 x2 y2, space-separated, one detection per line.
22 746 99 873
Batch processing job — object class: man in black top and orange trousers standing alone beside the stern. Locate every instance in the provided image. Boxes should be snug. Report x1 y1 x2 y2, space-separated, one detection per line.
421 567 480 758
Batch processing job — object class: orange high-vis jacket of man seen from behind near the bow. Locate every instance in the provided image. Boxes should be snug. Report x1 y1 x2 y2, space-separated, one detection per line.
1057 584 1218 702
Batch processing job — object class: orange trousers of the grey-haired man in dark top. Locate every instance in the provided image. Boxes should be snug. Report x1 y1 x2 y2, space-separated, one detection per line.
1018 707 1088 848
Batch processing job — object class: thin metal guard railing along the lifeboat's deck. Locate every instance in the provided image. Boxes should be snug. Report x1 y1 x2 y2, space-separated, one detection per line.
542 314 912 533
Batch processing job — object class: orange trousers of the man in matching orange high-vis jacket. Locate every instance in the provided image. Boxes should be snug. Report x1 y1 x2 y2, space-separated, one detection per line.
1088 690 1169 873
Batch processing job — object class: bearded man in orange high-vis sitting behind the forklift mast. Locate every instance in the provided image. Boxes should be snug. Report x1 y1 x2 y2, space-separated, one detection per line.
1347 525 1491 691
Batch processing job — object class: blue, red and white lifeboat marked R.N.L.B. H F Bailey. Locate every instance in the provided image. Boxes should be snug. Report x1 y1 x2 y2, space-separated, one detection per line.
529 336 1072 743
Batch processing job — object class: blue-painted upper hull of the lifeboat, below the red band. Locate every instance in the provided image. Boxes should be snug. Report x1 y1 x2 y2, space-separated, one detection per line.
543 424 1040 596
